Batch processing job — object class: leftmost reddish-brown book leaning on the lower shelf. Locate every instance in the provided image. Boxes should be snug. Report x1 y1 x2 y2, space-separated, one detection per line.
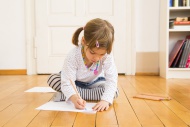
169 40 185 67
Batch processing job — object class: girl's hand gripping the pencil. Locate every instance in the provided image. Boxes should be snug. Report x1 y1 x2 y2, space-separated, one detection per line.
70 94 86 109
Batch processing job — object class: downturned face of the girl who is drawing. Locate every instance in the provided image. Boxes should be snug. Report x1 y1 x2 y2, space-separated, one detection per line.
84 45 107 63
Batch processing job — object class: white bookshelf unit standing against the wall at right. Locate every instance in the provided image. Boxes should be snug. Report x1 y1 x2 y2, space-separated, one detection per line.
160 0 190 78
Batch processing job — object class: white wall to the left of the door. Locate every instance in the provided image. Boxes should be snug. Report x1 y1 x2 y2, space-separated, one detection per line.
0 0 26 70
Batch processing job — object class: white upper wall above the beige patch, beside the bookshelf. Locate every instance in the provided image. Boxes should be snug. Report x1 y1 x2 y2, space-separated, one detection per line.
134 0 159 52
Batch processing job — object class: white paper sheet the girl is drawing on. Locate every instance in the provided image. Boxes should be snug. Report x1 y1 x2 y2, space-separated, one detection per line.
36 101 96 113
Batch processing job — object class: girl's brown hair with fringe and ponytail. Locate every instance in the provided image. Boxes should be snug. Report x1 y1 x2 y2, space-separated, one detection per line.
72 18 114 54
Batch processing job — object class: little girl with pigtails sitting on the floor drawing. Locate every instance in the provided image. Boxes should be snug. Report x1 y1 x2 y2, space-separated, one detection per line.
48 18 118 111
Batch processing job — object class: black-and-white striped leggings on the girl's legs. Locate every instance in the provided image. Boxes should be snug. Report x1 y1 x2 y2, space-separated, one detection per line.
47 73 119 101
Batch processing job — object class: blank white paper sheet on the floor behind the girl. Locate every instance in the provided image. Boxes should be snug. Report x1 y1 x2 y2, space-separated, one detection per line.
24 87 56 93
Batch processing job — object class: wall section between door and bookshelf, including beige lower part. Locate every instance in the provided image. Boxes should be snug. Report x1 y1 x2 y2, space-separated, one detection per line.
134 0 160 75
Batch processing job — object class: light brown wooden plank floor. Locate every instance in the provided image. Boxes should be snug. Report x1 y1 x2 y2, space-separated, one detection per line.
0 75 190 127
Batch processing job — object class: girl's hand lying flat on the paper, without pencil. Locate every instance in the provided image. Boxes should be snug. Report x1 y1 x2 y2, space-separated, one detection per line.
92 100 109 112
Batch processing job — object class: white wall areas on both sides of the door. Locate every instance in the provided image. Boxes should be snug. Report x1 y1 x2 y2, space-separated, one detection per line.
0 0 159 70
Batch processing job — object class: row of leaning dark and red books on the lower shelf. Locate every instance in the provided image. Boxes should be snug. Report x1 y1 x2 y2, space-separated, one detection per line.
169 35 190 68
